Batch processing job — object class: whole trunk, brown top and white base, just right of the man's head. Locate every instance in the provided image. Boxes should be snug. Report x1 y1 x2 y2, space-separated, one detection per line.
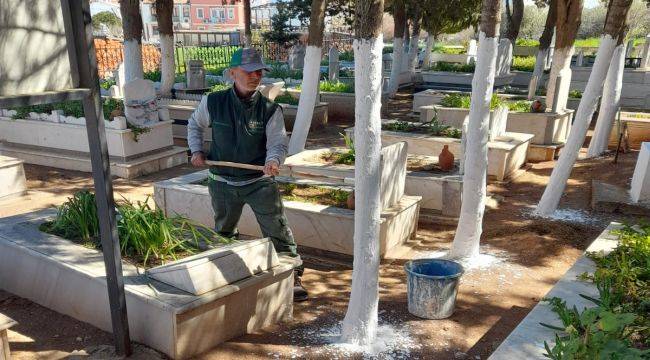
289 0 326 155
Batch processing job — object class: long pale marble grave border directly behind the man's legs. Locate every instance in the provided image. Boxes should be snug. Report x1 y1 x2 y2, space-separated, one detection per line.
154 170 420 258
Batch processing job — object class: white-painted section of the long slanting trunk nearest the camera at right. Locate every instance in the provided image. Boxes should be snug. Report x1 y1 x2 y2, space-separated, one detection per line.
536 35 616 216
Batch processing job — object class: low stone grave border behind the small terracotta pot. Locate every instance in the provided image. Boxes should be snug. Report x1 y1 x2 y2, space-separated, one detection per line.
345 127 533 181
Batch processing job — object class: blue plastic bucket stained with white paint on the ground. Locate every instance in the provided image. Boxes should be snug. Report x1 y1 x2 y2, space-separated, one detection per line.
404 259 464 319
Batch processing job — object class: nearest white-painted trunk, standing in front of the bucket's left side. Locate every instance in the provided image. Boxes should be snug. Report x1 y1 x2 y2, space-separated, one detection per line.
341 0 384 345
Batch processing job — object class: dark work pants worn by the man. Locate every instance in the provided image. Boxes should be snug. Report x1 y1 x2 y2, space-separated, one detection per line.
208 178 303 276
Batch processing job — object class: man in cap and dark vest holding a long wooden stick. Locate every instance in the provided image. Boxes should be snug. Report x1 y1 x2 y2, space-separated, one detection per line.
187 48 308 301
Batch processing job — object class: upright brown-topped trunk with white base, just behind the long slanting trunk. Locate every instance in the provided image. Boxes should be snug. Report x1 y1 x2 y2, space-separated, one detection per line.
546 0 582 110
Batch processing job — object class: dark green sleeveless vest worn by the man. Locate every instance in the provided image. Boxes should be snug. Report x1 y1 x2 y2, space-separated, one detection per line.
208 88 278 181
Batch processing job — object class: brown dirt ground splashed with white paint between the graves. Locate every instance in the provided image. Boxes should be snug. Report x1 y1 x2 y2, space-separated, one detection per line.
0 88 637 360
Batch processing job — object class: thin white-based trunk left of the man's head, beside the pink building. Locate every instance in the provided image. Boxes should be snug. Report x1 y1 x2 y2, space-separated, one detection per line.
155 0 176 96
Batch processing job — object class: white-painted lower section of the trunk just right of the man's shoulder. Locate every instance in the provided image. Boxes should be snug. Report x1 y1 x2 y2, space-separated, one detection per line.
288 45 321 155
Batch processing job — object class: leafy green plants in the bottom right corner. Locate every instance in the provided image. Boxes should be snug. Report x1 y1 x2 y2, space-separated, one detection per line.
542 224 650 359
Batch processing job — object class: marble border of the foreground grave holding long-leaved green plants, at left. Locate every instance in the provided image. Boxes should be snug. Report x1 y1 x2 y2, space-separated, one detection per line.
0 209 298 359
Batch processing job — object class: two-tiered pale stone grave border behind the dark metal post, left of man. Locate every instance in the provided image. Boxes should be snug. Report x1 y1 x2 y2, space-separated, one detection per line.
0 117 187 178
